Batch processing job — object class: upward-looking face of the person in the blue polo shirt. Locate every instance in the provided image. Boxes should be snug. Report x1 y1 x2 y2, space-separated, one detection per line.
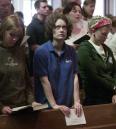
53 19 67 41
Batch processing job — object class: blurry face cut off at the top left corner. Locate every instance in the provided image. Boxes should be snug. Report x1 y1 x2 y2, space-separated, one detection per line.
0 0 11 20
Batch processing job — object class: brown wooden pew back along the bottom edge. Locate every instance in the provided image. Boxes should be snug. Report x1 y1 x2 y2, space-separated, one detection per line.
0 104 116 129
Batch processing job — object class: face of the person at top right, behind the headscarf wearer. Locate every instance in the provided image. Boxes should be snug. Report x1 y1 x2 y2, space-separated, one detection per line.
84 3 95 16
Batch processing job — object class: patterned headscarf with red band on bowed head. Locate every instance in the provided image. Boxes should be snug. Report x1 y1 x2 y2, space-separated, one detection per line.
88 16 112 32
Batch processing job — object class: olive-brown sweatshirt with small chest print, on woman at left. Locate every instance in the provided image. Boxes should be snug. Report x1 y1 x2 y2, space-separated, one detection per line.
0 45 34 113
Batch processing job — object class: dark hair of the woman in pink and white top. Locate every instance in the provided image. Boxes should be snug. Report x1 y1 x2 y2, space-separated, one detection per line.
63 2 81 14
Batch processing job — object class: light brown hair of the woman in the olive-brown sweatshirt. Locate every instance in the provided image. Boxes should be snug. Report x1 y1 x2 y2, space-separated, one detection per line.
0 15 25 44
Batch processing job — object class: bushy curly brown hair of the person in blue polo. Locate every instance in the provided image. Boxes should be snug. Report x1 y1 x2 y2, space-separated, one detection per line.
45 12 72 40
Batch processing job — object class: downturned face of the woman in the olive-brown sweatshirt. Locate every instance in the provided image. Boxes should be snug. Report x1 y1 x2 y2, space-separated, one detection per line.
3 28 22 47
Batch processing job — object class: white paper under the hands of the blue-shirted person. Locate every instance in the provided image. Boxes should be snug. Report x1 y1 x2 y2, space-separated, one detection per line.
65 109 86 126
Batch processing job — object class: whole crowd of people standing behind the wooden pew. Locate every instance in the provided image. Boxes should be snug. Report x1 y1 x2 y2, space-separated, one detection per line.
0 0 116 116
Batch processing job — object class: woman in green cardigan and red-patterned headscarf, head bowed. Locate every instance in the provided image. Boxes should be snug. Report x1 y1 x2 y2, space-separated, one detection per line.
78 16 116 105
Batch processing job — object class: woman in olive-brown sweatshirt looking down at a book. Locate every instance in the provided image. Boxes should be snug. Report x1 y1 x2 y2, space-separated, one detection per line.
0 15 34 114
